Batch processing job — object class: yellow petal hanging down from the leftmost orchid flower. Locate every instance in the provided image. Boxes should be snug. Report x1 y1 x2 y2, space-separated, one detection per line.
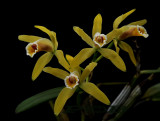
32 52 53 81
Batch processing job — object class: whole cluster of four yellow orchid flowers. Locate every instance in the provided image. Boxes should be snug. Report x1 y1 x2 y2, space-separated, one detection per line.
18 9 148 115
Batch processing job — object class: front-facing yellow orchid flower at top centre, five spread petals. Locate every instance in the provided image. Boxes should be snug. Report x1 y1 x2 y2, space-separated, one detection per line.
71 14 126 71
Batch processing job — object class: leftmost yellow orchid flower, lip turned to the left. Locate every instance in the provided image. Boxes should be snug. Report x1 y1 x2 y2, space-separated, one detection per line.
18 26 58 81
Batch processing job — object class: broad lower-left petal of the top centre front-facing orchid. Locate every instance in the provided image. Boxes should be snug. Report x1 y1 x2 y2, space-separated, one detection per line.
71 48 96 68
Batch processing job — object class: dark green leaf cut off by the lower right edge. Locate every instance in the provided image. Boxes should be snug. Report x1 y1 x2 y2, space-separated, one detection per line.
142 83 160 101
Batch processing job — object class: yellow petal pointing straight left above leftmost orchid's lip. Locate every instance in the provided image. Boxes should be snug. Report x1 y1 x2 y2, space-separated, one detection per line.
18 35 42 42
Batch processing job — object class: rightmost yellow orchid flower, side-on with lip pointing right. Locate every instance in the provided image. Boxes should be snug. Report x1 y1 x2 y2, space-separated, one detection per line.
113 9 149 66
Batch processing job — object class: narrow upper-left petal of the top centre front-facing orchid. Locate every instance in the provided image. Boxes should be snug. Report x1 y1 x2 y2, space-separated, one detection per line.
73 26 94 47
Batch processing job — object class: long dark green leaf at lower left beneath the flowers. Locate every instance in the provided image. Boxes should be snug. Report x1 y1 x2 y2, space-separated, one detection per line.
15 87 64 113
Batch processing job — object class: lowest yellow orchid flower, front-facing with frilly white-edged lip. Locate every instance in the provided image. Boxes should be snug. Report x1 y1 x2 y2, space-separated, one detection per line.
43 53 110 115
